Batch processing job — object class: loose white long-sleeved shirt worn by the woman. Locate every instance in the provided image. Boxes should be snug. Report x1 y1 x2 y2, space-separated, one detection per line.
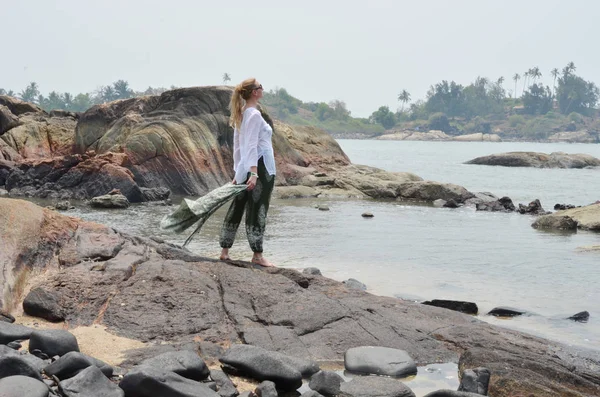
233 107 275 183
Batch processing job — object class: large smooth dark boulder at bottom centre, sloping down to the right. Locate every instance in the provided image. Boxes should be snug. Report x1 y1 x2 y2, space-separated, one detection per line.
219 345 302 390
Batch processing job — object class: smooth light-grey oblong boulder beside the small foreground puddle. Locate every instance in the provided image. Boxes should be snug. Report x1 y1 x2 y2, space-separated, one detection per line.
344 346 417 377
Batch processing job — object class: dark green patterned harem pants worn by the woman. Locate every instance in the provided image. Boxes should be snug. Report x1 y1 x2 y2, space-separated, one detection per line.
219 157 275 253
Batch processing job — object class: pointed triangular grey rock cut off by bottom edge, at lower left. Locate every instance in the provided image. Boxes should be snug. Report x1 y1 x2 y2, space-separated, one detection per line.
58 366 125 397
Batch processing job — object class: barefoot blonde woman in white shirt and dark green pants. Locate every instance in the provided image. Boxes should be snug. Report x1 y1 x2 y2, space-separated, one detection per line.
220 78 275 267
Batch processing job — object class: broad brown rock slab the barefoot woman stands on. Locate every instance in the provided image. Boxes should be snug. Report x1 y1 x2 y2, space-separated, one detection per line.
0 198 600 397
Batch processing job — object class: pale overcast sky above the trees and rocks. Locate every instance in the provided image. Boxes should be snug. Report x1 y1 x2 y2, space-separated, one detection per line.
0 0 600 117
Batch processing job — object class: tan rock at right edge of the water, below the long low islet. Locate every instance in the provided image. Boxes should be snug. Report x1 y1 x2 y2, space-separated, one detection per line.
532 203 600 231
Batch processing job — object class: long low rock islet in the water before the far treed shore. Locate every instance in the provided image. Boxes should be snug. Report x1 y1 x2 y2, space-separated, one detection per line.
465 152 600 168
